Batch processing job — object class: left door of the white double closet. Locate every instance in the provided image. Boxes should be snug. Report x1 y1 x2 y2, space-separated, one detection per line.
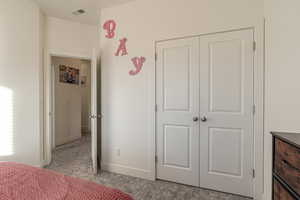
156 37 199 186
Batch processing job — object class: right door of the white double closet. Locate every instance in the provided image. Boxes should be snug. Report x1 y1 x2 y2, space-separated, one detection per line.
200 30 254 196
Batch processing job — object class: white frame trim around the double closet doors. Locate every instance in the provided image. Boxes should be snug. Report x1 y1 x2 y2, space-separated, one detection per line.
154 24 265 199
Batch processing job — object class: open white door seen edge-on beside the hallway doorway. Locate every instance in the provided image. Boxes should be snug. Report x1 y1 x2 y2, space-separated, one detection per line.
90 50 101 174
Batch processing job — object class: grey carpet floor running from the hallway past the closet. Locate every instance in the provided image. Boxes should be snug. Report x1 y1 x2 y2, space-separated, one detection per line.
48 136 249 200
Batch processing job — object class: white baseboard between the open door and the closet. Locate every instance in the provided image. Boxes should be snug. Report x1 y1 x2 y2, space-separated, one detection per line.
101 163 155 180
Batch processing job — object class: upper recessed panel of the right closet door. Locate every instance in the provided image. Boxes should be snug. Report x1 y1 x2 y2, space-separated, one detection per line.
209 39 244 113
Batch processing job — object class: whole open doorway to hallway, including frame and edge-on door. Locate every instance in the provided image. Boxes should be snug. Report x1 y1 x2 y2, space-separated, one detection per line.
45 54 101 174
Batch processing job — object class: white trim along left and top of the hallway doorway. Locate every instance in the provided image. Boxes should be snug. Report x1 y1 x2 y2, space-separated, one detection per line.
41 52 93 167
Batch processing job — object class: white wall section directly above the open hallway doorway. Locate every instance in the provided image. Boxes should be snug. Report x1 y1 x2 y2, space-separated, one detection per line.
47 17 98 58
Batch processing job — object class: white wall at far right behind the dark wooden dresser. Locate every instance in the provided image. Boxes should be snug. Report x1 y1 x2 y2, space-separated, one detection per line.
265 0 300 200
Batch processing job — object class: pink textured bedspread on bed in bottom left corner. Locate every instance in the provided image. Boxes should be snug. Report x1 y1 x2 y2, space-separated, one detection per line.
0 162 132 200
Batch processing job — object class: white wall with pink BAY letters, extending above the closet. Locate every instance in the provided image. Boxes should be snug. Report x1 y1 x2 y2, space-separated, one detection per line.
101 0 263 192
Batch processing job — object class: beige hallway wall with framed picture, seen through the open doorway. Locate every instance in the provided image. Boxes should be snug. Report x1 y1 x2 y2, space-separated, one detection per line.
51 56 91 150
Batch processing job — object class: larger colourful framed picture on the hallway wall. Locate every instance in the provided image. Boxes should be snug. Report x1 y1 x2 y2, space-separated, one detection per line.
59 65 79 85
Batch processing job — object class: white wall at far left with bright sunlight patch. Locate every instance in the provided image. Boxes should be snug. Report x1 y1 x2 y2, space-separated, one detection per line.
0 0 43 166
